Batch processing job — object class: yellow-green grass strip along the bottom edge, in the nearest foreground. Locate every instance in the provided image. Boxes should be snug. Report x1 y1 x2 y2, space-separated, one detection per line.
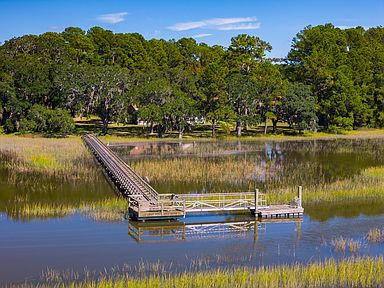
16 256 384 288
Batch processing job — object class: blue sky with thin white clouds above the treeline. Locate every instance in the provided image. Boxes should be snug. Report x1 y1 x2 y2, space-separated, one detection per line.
0 0 384 57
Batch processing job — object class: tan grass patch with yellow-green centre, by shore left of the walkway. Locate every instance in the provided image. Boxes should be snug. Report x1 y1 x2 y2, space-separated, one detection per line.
0 135 96 181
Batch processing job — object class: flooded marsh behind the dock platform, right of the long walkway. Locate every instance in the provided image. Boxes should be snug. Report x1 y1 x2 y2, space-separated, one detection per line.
124 139 384 204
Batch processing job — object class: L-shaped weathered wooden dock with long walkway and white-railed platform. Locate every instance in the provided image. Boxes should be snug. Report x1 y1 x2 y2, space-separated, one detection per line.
83 134 304 221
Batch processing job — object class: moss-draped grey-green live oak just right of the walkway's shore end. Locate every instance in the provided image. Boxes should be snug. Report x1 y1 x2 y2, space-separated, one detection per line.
55 64 133 134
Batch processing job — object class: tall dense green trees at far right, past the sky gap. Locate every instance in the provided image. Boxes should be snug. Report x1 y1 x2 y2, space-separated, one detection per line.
287 24 384 129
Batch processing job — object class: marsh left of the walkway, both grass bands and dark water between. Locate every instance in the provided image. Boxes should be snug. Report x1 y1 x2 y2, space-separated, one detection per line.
0 135 127 221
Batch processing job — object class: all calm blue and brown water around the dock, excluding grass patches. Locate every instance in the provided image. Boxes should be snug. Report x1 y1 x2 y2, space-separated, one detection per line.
0 140 384 284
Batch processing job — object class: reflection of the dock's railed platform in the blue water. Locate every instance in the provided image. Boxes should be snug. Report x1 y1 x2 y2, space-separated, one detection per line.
128 218 303 243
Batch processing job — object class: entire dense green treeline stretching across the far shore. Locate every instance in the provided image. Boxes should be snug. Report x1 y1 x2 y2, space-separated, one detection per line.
0 24 384 136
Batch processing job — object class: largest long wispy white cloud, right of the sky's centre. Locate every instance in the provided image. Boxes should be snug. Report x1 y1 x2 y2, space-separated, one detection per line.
168 17 260 31
